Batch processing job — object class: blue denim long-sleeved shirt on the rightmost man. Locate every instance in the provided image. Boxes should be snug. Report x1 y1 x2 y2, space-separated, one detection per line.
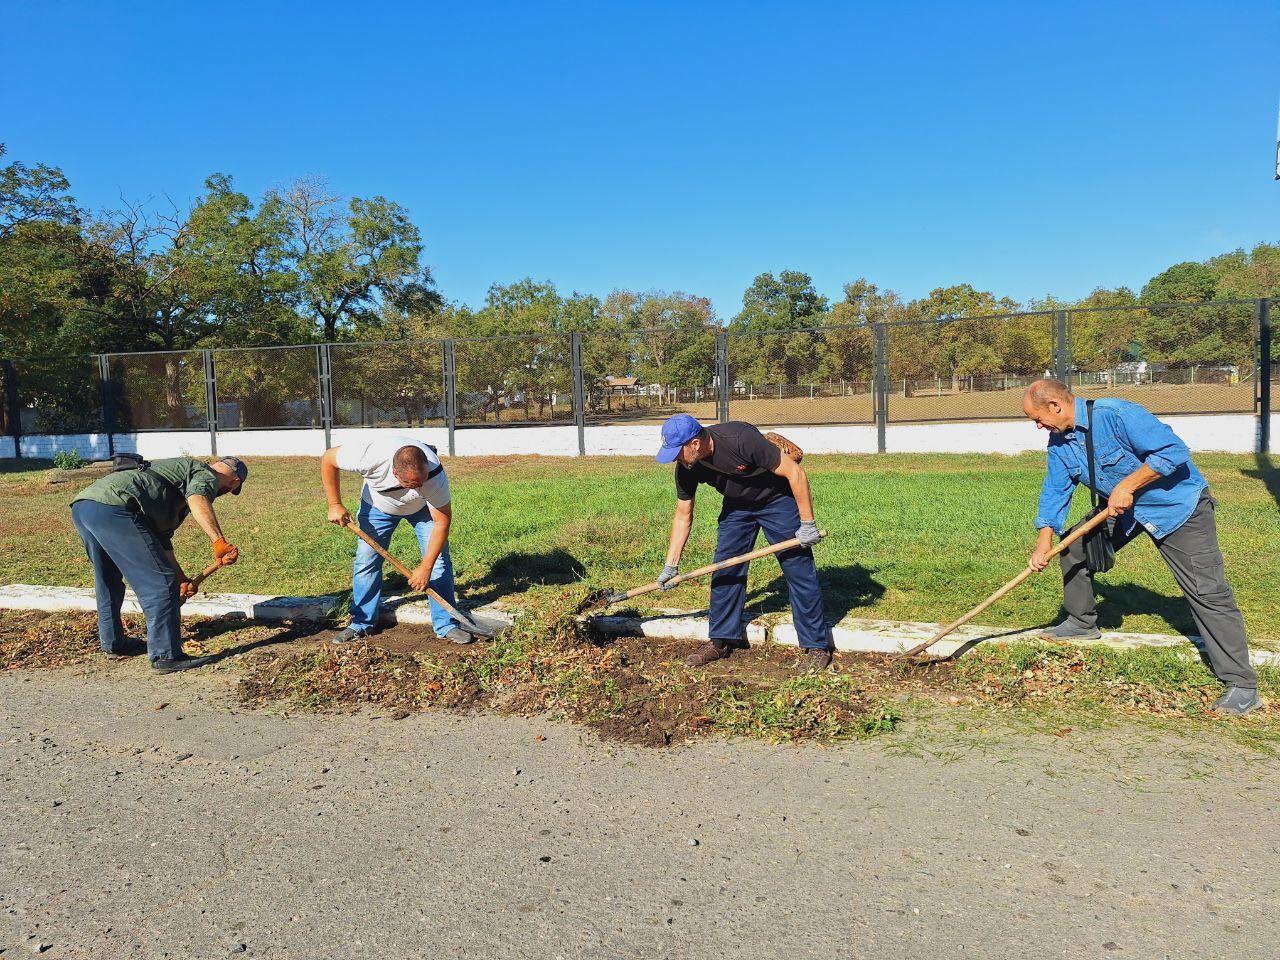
1036 398 1208 538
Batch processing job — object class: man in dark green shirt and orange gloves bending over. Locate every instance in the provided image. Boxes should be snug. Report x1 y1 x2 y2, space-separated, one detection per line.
72 457 248 673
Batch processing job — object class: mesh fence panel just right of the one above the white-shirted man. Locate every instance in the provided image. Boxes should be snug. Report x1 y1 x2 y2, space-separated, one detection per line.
453 335 573 425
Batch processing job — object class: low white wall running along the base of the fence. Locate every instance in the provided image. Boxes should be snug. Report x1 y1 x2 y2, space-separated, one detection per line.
0 413 1257 460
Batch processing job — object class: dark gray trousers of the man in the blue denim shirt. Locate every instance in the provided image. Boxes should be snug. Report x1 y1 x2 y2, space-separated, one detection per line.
1060 490 1258 690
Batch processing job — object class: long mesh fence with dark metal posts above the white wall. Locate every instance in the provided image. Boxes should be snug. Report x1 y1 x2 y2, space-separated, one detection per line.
0 300 1280 452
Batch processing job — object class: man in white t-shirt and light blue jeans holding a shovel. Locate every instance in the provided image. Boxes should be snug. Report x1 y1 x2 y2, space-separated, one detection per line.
320 434 475 644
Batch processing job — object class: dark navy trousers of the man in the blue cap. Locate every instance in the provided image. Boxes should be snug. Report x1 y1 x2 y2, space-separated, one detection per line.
709 497 831 650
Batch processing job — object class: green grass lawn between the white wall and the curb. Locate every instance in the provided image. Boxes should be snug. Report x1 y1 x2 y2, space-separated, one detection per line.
0 454 1280 640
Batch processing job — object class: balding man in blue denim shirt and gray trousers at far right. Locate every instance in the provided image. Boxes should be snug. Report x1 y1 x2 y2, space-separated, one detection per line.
1023 380 1262 716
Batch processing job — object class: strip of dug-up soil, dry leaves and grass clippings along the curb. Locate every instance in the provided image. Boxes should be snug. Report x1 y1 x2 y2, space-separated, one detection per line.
0 601 1280 755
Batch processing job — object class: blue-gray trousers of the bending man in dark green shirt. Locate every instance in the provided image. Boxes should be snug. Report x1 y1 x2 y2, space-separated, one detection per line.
72 500 182 660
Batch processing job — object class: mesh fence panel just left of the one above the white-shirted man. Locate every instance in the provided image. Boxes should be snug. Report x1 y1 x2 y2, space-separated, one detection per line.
214 347 320 430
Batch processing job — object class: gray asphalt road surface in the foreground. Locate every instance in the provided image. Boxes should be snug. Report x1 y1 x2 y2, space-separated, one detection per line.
0 664 1280 960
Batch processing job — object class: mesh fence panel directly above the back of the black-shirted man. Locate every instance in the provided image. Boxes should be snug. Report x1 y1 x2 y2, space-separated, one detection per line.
728 326 873 426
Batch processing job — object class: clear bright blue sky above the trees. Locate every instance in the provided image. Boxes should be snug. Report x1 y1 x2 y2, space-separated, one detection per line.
0 0 1280 316
